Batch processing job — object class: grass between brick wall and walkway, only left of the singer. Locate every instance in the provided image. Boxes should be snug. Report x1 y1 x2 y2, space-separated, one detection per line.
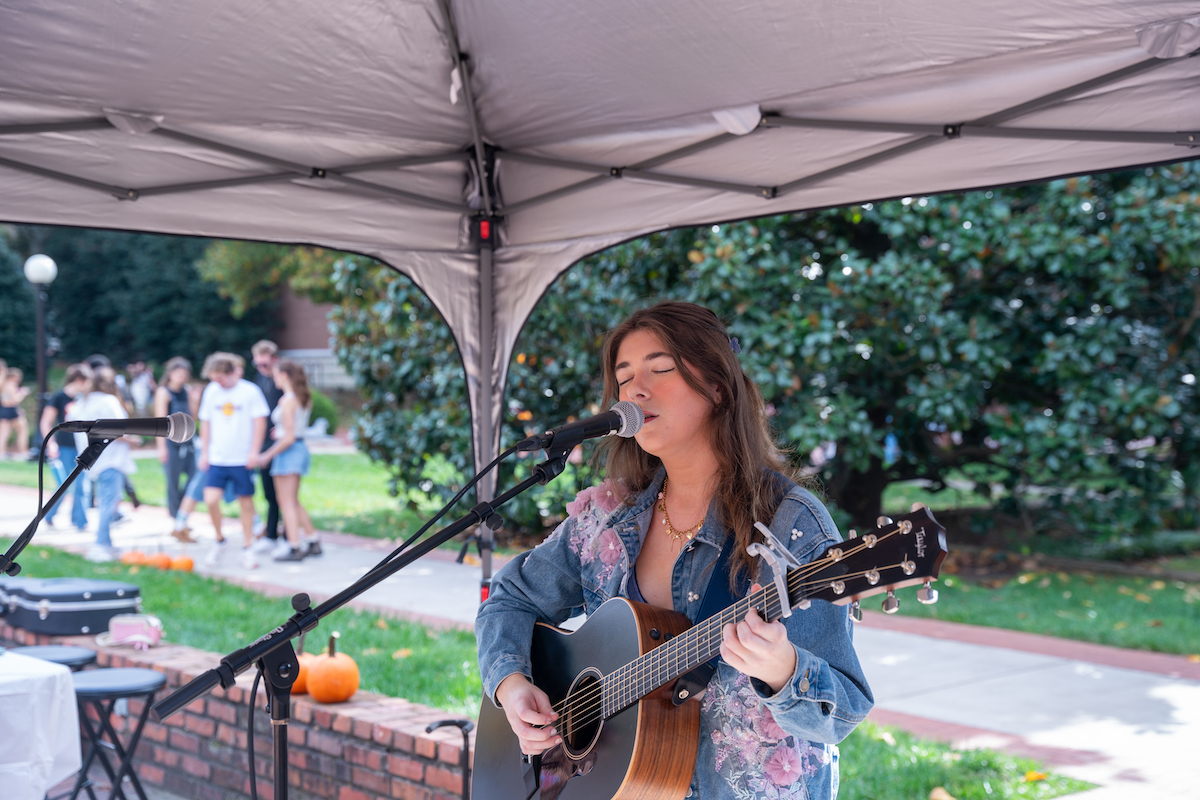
2 540 482 717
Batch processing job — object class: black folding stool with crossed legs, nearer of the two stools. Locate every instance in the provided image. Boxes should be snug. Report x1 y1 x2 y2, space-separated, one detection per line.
70 667 167 800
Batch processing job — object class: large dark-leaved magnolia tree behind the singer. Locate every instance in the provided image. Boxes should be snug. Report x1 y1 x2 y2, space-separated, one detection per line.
201 163 1200 551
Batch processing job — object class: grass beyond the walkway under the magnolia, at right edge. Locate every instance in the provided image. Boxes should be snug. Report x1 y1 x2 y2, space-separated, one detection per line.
897 572 1200 655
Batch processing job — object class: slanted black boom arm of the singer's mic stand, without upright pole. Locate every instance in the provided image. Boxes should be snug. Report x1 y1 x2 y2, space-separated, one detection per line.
151 452 566 721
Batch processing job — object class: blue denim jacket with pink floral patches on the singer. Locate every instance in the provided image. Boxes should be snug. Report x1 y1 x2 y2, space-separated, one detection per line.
475 469 874 800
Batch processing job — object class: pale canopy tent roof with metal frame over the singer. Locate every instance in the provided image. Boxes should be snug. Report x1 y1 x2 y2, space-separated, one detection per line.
0 0 1200 576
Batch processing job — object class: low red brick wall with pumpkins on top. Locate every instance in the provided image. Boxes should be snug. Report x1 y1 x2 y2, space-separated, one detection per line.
0 622 474 800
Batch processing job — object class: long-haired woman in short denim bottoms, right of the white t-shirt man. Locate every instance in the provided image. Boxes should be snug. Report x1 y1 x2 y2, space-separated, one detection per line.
260 359 320 561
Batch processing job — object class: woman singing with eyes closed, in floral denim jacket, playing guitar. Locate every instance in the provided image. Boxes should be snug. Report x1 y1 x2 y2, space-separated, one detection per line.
475 302 874 800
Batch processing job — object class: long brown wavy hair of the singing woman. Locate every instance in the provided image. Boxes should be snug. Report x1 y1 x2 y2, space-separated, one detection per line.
592 301 794 588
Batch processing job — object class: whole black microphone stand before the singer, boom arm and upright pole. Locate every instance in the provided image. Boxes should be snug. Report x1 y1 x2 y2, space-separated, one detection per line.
151 450 573 800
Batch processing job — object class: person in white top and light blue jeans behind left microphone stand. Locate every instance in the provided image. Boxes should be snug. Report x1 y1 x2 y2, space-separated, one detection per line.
71 367 137 563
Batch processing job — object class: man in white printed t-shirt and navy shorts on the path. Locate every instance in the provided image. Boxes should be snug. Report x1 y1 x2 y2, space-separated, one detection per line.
197 353 270 570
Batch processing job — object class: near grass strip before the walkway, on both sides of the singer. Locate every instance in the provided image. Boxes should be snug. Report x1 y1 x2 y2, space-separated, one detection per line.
0 540 1090 800
